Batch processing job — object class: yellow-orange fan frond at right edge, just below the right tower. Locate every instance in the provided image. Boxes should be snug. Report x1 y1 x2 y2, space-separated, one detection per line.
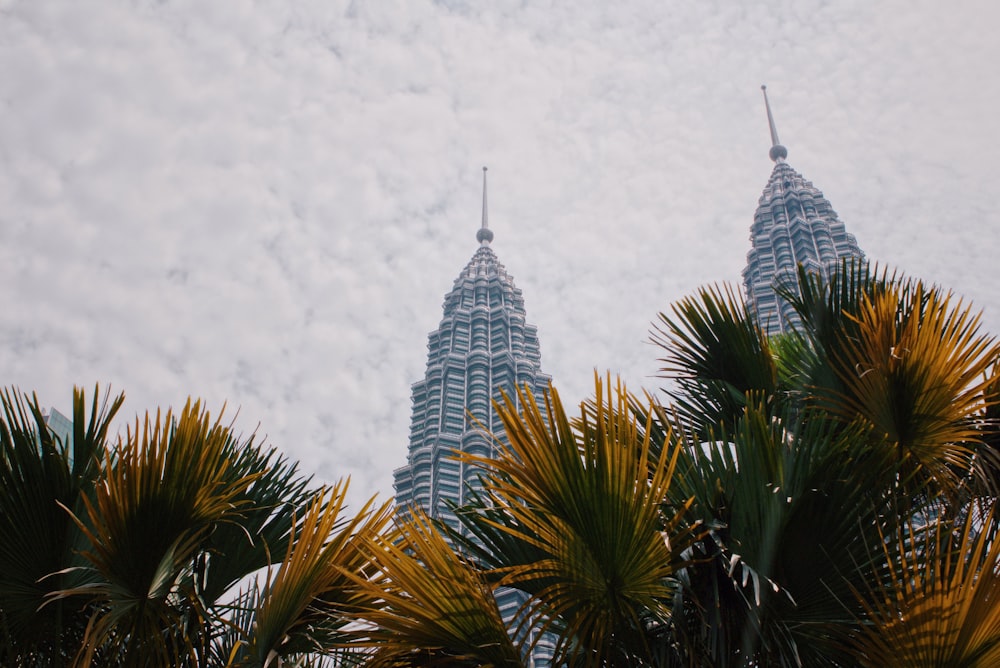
833 283 998 494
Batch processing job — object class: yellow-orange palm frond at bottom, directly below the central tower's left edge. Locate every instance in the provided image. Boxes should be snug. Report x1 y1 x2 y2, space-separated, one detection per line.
346 510 523 668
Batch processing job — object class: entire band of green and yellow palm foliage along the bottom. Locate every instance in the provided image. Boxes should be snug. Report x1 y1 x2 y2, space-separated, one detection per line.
0 264 1000 668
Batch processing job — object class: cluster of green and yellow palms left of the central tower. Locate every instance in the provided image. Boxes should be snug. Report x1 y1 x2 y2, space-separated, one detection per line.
0 391 390 666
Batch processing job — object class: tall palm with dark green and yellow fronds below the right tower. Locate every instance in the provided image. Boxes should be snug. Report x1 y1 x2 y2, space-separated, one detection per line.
648 263 998 666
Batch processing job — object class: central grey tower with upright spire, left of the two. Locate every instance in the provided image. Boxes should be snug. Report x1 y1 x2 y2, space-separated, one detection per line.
394 167 549 526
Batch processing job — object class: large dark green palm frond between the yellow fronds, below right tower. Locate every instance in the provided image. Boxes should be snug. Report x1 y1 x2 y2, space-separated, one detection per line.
671 396 894 666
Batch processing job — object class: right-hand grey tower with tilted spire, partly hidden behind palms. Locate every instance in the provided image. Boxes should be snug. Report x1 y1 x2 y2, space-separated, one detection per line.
743 86 864 335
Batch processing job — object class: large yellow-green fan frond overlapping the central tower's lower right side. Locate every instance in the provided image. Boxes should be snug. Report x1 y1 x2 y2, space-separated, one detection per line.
465 378 698 664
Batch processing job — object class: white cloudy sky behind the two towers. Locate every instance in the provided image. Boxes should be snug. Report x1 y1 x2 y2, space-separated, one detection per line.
0 0 1000 498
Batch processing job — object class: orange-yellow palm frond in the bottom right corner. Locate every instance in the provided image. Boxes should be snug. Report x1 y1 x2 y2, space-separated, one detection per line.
850 507 1000 668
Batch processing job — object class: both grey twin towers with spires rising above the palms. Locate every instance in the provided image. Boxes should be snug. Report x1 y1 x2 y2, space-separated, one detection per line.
395 81 863 556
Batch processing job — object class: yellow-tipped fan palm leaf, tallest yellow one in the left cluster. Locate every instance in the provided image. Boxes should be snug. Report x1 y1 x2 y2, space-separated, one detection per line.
49 401 262 665
